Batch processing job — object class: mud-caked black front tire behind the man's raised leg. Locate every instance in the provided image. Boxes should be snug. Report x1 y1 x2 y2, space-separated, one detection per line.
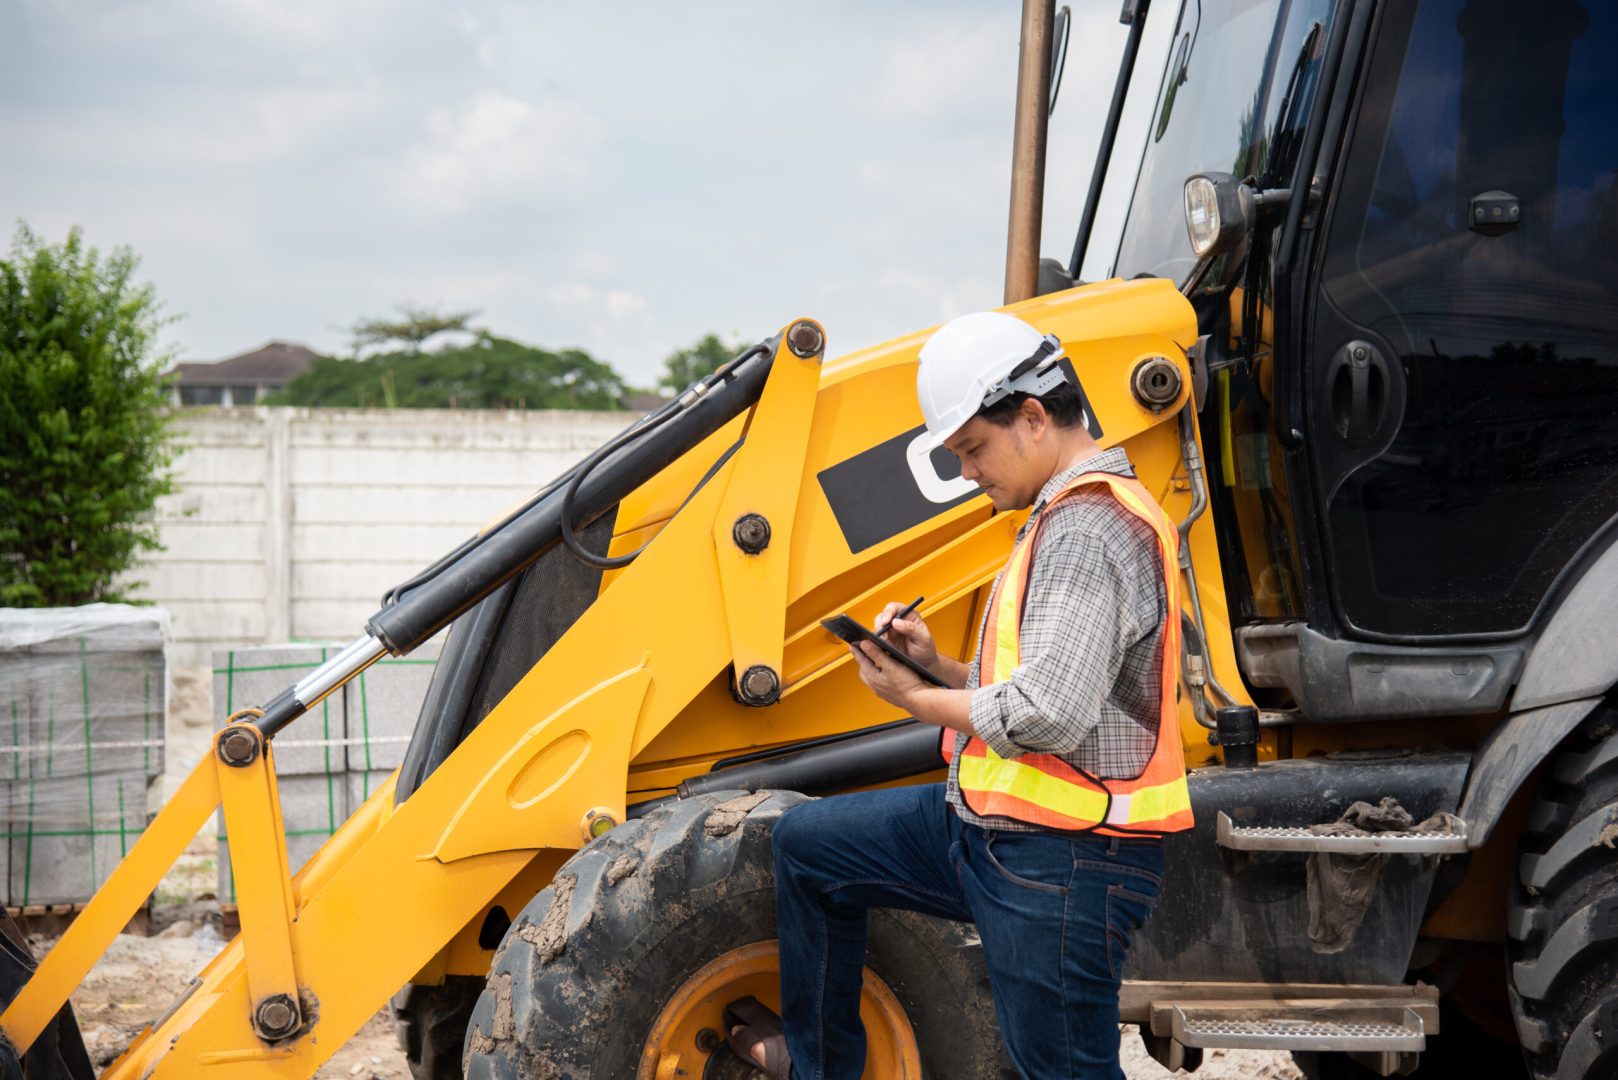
466 792 1016 1080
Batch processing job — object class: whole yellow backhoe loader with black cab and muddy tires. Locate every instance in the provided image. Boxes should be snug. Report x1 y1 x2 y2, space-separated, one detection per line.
0 0 1618 1080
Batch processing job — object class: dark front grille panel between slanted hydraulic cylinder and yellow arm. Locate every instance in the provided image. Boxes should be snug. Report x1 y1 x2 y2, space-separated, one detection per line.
466 510 618 730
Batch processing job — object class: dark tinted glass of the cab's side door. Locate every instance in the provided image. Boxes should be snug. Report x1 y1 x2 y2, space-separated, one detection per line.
1312 0 1618 635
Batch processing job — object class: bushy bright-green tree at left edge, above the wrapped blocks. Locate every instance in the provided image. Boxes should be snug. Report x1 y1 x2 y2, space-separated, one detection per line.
0 225 173 607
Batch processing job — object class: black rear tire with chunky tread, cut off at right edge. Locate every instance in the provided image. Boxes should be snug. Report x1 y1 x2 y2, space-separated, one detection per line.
1506 708 1618 1080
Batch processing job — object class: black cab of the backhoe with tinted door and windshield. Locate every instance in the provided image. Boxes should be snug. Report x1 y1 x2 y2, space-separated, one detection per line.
1076 0 1618 721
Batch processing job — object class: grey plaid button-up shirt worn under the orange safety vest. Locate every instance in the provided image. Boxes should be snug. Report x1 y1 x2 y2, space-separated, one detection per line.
947 447 1167 832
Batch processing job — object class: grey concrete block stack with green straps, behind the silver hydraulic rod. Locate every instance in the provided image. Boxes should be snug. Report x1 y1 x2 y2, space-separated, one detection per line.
214 643 438 904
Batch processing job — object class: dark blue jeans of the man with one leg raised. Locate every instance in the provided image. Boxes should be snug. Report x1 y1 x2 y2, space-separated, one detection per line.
773 784 1163 1080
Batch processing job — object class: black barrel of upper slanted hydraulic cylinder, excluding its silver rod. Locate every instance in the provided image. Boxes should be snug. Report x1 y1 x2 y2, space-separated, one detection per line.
366 342 775 656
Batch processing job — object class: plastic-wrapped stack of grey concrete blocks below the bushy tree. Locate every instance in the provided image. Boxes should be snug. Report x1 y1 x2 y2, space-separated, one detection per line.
0 604 168 907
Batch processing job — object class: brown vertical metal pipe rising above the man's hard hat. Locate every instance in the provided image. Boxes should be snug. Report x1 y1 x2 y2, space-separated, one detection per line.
1005 0 1057 304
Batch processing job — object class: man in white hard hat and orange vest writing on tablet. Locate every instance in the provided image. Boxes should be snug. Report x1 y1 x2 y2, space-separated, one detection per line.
726 311 1191 1080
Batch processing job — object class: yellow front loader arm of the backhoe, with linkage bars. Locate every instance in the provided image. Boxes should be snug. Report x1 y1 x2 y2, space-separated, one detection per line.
0 282 1223 1078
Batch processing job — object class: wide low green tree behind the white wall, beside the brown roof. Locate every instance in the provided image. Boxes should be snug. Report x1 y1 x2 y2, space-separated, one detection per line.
269 332 625 410
